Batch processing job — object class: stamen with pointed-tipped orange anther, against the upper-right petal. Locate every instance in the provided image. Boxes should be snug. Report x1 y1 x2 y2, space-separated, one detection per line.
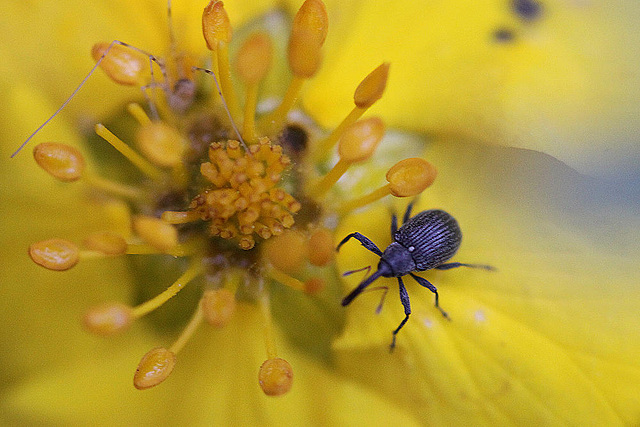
313 62 389 160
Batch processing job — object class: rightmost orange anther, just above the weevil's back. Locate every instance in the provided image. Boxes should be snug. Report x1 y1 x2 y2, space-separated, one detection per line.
386 158 438 197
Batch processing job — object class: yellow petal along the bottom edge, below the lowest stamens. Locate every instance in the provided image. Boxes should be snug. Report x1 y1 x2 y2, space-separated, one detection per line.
3 305 420 426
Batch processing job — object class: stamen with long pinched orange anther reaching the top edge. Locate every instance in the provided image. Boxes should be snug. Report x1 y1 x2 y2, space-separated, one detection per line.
265 0 329 132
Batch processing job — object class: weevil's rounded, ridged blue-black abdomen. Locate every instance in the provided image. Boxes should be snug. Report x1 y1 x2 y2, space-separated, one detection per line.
394 210 462 271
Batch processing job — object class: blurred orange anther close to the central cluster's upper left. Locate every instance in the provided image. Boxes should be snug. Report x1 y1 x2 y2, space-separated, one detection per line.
136 122 187 167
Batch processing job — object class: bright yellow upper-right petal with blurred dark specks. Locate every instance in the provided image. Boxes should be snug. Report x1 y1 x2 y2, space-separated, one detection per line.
304 0 640 174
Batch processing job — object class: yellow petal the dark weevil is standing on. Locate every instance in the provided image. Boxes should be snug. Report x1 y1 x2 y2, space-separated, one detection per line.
335 141 640 425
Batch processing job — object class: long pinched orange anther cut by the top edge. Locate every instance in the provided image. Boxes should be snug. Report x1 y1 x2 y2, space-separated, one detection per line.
288 0 329 79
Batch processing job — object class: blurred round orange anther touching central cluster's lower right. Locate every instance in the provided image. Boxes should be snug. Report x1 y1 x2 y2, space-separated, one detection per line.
264 230 307 273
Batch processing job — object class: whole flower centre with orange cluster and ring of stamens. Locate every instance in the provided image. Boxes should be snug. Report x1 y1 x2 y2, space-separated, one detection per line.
23 0 436 395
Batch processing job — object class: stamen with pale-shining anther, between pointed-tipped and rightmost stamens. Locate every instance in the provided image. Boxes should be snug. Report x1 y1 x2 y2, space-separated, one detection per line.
308 117 385 198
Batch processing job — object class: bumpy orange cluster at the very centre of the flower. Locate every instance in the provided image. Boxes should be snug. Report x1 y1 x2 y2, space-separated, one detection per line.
189 138 301 250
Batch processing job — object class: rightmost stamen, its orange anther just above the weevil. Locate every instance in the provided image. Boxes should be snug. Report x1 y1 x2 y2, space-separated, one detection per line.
339 158 437 215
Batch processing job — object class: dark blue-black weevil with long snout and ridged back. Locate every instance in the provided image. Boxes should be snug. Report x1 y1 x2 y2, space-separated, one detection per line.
336 202 494 351
